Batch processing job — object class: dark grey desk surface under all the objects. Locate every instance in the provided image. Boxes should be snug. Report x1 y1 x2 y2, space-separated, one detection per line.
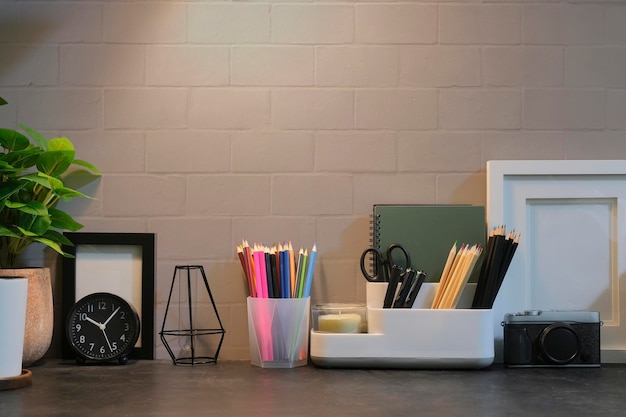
0 359 626 417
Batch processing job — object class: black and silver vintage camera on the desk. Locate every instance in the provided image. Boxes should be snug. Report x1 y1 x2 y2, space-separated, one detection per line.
502 310 602 367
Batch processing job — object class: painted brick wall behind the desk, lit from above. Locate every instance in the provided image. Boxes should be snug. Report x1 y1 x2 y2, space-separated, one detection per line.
0 0 626 359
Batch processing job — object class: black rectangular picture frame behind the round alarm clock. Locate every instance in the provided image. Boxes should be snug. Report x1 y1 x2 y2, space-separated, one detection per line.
61 232 156 359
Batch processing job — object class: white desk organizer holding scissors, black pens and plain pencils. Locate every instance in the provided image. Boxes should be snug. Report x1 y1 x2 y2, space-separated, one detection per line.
310 282 494 369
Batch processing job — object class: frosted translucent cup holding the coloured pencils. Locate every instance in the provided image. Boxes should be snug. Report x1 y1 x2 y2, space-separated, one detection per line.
247 297 311 368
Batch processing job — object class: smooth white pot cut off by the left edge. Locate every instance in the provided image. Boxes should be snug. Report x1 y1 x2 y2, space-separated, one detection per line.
0 276 28 378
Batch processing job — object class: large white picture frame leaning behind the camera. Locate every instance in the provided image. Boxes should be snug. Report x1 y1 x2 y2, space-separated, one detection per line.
487 160 626 363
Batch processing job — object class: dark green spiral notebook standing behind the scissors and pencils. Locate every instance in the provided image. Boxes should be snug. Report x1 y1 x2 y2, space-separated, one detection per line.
371 204 487 282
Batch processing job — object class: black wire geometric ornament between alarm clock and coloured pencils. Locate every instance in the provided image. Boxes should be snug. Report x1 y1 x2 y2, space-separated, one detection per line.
159 265 226 365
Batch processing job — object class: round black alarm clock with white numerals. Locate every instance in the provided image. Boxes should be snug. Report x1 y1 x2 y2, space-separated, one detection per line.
66 292 140 365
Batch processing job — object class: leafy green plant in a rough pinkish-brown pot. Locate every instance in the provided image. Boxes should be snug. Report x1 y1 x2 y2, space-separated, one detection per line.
0 97 100 364
